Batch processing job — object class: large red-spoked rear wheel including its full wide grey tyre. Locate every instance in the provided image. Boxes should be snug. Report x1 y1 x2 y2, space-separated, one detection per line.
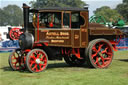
86 39 113 68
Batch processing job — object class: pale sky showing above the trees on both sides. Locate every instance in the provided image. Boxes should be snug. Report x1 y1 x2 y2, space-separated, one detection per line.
0 0 122 16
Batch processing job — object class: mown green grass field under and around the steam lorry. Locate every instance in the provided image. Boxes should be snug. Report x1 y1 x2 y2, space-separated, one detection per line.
0 51 128 85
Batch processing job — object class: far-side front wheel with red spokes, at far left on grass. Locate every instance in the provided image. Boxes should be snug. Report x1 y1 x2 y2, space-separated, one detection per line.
9 49 25 71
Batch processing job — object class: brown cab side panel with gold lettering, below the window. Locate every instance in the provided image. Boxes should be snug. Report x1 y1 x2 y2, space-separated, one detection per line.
39 29 72 47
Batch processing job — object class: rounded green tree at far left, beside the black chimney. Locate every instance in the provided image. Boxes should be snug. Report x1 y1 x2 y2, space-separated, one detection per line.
0 5 23 26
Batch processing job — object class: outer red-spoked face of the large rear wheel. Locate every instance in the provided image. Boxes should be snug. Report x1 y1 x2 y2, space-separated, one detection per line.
90 41 113 68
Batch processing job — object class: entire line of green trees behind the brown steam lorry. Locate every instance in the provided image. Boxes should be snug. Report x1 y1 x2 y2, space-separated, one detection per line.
0 0 128 26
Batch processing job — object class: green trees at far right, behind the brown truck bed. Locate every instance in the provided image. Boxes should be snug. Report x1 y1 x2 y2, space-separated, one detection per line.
94 0 128 23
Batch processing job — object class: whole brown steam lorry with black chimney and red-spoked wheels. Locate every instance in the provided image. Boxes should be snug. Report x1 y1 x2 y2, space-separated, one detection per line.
9 4 122 72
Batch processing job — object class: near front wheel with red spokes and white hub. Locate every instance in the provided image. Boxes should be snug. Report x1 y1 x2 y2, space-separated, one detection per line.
26 49 48 72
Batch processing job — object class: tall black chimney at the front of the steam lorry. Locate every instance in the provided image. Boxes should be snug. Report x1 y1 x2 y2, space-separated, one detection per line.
23 3 30 32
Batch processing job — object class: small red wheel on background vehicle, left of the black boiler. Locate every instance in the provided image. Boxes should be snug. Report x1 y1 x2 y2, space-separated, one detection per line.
9 28 22 40
